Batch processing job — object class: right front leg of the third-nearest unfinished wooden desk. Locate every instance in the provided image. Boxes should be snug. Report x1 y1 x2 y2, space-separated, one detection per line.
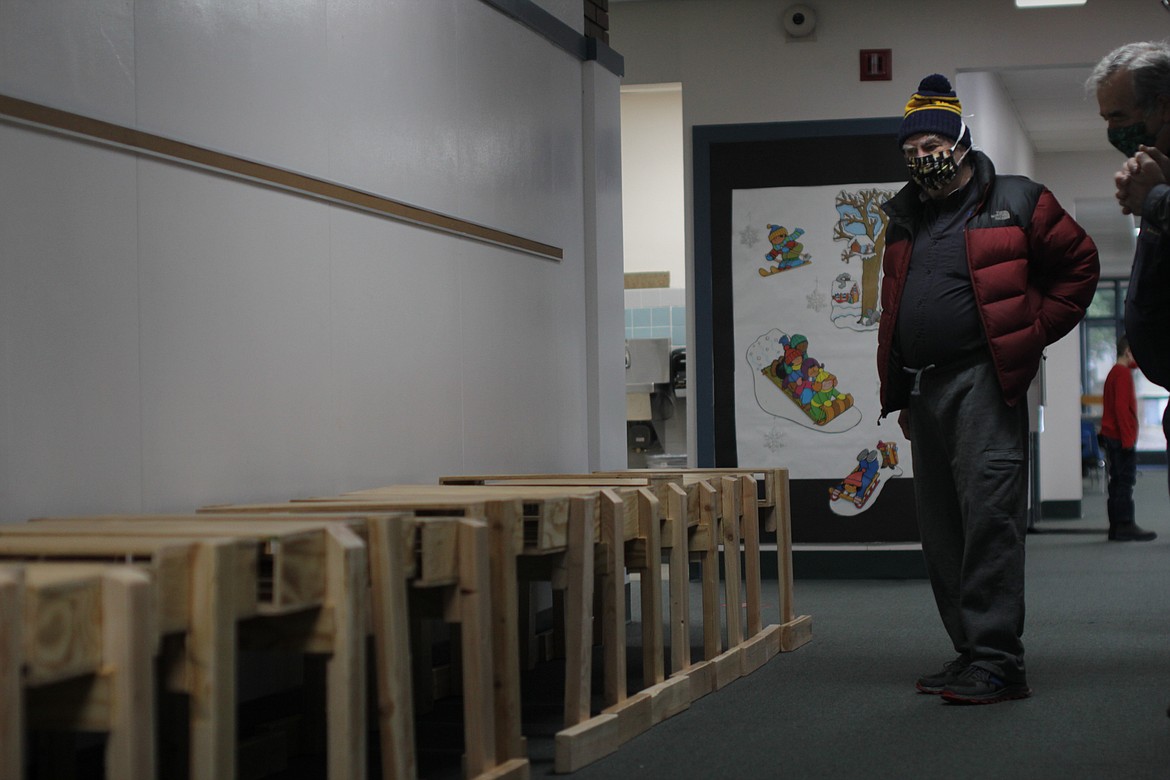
457 520 496 778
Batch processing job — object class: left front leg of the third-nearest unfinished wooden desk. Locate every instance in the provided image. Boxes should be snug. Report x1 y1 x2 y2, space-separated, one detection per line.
367 518 418 780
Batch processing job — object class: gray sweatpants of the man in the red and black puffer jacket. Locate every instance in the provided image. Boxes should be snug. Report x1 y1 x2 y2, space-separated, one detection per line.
910 358 1027 679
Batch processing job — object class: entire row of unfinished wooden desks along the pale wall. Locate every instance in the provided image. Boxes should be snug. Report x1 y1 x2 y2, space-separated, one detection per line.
0 470 811 780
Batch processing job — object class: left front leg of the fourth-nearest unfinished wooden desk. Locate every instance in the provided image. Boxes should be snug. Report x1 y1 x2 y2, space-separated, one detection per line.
484 502 528 762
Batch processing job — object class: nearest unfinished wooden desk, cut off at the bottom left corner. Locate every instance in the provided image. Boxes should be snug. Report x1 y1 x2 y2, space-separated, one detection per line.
0 564 158 780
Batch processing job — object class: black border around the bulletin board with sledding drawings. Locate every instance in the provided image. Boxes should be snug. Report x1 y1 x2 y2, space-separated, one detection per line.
688 117 918 543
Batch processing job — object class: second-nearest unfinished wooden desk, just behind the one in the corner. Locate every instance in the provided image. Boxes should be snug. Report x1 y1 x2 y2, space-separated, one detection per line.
0 516 367 779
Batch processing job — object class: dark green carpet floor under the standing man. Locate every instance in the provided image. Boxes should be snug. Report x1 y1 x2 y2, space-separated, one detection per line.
532 469 1170 780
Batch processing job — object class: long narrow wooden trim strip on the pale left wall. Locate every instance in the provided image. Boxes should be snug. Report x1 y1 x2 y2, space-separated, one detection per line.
0 95 564 261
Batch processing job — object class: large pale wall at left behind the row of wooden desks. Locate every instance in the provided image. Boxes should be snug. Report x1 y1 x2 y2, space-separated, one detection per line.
0 0 625 522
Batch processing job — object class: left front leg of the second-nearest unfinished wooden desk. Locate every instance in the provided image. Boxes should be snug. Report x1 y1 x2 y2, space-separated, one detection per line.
187 541 237 780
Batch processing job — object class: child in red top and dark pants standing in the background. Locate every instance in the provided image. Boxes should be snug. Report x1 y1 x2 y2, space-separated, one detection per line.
1100 336 1157 541
